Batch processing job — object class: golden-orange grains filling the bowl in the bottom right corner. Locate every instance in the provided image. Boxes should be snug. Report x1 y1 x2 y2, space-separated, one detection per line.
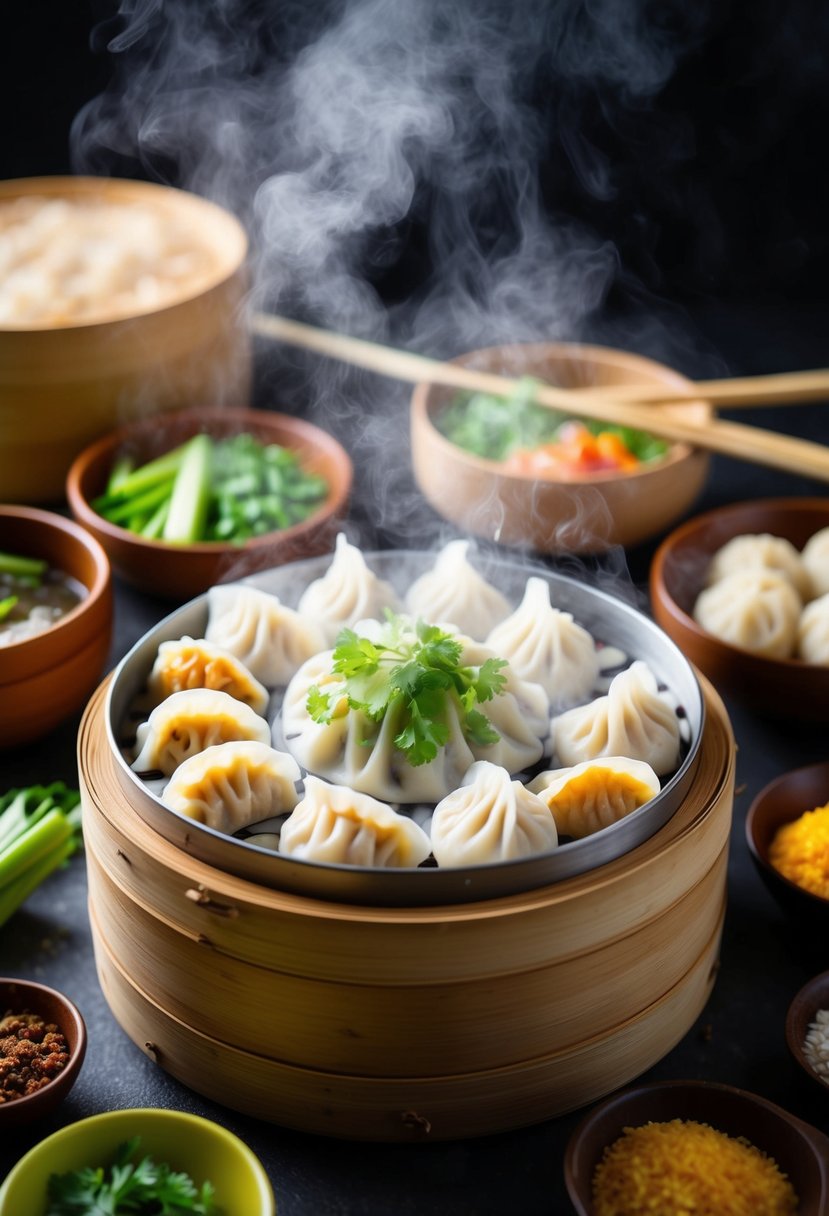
593 1119 797 1216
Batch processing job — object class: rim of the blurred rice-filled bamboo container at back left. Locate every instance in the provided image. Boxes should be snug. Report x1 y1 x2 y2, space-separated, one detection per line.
0 174 249 334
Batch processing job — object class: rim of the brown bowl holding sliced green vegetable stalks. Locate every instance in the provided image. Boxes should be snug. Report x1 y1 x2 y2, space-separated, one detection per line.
66 407 354 561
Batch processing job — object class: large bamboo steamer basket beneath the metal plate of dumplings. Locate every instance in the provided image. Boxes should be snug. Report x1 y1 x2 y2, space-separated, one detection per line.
79 682 734 1141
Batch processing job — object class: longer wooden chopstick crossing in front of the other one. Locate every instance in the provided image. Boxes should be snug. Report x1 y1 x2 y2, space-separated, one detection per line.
250 313 829 482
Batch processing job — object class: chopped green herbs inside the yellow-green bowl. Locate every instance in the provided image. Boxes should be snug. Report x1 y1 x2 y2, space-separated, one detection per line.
46 1136 220 1216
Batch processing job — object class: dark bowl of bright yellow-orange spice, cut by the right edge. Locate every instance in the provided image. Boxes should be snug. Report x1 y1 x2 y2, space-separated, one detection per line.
745 762 829 929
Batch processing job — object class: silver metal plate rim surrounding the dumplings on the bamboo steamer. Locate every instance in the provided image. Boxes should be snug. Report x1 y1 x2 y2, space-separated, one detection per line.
105 550 705 907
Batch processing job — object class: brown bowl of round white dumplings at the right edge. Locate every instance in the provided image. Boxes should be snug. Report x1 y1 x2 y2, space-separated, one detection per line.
650 499 829 721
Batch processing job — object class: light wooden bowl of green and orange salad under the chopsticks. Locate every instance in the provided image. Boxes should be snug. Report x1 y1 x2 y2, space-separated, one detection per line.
411 343 711 553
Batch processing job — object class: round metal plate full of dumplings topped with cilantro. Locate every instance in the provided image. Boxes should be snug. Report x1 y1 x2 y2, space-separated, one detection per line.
106 534 704 905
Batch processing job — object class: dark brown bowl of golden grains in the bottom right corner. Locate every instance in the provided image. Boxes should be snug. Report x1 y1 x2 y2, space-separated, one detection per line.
564 1081 829 1216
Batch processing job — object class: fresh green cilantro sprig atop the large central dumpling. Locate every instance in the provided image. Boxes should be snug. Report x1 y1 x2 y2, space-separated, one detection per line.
306 613 507 767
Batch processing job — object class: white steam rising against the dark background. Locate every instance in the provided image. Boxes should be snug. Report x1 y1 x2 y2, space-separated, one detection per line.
73 0 707 559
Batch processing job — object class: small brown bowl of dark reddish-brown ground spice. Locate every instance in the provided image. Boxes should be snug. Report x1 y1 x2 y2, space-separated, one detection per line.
0 979 86 1133
